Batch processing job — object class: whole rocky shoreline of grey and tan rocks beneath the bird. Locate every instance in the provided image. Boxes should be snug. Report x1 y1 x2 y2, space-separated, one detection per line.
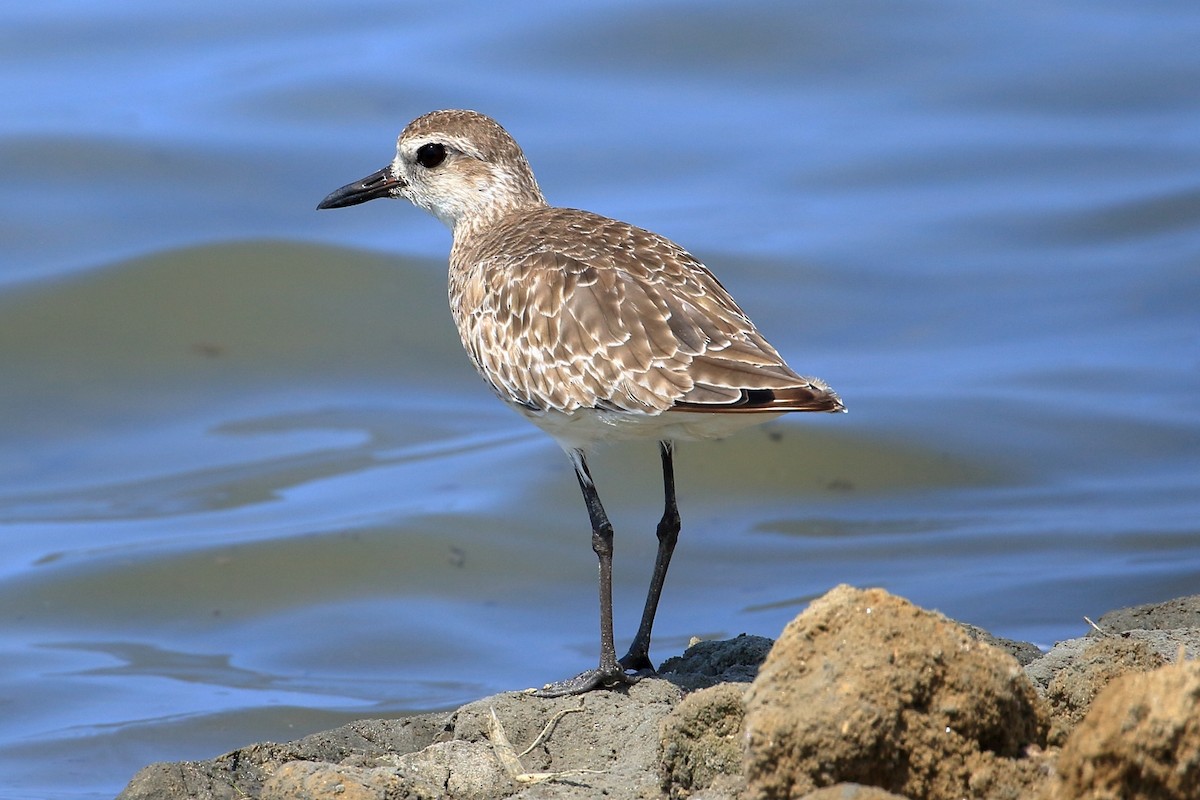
119 587 1200 800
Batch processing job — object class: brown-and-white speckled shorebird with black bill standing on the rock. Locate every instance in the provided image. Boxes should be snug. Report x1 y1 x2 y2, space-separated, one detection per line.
317 110 845 697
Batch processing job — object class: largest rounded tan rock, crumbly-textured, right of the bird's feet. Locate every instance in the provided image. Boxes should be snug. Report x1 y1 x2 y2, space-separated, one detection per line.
745 587 1048 800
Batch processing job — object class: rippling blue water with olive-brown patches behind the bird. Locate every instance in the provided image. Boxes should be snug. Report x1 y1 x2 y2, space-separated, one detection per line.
0 0 1200 800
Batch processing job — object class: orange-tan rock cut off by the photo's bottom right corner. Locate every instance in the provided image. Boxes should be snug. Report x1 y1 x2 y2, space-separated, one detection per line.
1043 661 1200 800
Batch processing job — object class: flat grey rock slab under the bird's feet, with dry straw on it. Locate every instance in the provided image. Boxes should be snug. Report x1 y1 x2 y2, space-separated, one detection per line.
120 643 720 800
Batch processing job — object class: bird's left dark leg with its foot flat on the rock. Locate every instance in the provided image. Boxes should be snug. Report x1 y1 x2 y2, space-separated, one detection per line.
536 450 637 697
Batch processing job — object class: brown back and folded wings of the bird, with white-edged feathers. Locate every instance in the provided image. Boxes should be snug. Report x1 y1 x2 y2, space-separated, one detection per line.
450 205 842 415
